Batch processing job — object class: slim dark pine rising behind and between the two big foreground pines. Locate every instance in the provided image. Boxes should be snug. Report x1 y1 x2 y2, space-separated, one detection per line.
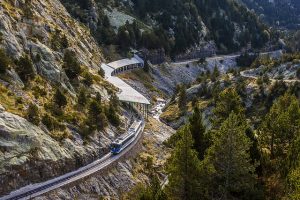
189 107 209 160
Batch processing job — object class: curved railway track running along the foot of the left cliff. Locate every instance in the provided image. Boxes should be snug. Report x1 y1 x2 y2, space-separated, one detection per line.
0 109 145 200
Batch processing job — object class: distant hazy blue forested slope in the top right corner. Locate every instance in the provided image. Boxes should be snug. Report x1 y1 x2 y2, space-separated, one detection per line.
242 0 300 30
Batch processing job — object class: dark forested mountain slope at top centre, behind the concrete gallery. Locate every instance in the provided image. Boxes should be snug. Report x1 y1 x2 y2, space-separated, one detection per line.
61 0 268 56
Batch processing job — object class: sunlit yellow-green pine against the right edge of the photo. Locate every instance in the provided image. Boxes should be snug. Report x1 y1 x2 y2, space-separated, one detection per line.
260 94 300 159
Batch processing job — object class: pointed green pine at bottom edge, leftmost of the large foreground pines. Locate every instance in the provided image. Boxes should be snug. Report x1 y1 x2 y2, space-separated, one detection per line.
166 126 201 200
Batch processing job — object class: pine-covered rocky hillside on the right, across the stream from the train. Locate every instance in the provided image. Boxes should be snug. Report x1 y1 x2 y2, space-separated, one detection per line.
150 53 300 200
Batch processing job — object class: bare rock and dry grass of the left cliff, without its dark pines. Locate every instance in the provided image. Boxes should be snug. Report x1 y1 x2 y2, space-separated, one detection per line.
0 0 122 195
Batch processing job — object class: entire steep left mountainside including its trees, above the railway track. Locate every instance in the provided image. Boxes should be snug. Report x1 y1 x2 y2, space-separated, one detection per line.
0 0 122 195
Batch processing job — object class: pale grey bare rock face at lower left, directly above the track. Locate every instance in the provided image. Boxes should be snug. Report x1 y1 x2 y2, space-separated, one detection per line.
0 109 115 195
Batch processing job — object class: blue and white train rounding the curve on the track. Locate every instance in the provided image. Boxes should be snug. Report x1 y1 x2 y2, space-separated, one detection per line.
110 120 143 155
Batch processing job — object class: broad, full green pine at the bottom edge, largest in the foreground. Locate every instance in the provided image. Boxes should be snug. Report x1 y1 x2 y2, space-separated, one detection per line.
206 112 256 199
